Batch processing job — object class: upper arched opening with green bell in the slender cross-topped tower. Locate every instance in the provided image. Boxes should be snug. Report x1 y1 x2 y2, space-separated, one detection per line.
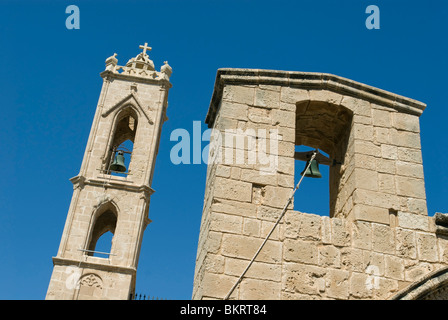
106 107 138 176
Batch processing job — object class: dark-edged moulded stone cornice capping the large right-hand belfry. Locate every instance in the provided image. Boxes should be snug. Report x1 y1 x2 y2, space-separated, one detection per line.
205 68 426 127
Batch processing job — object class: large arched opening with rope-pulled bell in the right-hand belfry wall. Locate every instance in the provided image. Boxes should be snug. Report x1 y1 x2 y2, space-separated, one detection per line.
294 100 353 217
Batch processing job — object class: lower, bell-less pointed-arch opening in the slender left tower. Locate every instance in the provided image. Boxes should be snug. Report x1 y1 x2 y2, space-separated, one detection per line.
87 210 117 258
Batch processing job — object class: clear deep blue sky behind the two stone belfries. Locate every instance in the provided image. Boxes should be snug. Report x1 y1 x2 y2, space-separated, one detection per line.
0 0 448 299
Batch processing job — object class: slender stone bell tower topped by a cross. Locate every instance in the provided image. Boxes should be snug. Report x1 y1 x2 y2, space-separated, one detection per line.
46 43 172 299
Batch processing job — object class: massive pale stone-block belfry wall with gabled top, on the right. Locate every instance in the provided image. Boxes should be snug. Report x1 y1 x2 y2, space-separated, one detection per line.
193 69 448 299
